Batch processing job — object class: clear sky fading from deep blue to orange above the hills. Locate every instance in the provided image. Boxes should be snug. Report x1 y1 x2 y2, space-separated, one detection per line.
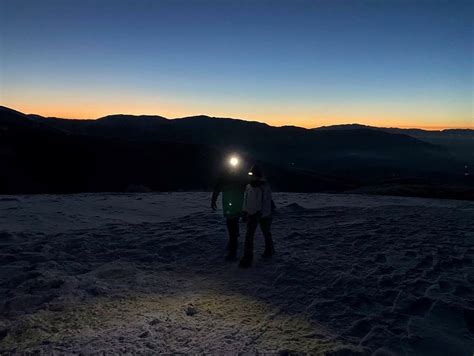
0 0 474 129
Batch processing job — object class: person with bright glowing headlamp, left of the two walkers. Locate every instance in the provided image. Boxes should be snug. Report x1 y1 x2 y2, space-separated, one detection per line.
211 156 247 261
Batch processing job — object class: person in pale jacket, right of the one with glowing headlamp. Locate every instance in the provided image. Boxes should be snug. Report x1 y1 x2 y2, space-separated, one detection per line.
239 165 274 268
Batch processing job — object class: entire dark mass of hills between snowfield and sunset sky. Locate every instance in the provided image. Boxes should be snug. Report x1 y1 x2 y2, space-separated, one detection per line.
0 108 474 197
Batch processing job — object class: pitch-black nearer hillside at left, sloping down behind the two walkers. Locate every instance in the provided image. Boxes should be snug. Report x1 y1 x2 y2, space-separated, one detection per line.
0 107 353 194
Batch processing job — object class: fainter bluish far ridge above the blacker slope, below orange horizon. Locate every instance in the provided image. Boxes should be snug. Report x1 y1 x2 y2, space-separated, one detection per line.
25 110 460 180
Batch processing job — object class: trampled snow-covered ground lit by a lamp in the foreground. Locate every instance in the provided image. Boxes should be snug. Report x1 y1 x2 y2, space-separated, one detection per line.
0 193 474 356
